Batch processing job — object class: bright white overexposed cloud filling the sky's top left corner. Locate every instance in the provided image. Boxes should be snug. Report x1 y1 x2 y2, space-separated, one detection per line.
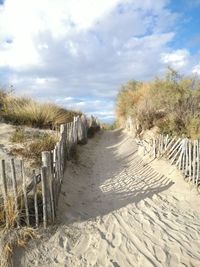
0 0 123 68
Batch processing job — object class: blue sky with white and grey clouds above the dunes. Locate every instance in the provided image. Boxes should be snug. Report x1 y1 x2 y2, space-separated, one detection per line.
0 0 200 122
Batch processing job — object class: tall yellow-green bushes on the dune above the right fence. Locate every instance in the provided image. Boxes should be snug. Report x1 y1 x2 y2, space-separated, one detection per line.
116 68 200 138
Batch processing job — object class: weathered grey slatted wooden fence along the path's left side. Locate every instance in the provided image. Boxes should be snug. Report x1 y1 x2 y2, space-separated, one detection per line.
0 116 100 228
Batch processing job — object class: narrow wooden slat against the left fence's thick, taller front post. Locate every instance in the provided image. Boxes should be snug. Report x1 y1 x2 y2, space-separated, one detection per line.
41 166 47 228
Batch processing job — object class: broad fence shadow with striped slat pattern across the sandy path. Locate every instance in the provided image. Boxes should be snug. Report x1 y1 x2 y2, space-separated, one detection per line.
59 130 174 223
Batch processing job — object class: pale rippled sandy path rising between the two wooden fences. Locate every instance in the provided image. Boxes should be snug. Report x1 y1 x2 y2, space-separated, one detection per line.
14 131 200 267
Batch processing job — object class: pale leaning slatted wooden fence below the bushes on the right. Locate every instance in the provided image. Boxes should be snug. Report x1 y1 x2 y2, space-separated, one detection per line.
141 135 200 187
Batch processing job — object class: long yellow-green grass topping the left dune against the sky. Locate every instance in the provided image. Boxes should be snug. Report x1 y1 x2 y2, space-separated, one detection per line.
0 90 81 129
